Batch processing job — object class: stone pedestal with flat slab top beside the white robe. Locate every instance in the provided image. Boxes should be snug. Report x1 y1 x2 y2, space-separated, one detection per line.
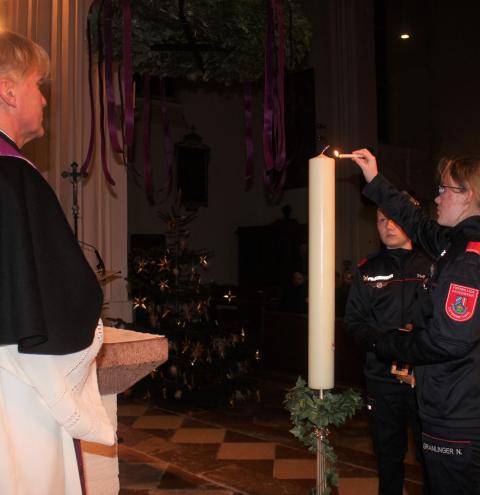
82 327 168 495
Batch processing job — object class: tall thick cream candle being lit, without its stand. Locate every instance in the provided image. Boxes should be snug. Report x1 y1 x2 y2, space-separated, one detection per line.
308 154 335 390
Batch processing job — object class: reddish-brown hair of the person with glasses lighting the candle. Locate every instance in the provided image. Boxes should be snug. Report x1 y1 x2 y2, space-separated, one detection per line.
438 156 480 206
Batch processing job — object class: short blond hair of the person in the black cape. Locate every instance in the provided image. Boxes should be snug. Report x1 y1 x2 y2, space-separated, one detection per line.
0 31 50 80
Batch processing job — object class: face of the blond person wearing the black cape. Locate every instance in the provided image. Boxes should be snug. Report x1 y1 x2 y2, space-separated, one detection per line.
15 70 47 148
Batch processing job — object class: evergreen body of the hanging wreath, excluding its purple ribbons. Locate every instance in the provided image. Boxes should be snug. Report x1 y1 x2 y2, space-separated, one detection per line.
91 0 311 85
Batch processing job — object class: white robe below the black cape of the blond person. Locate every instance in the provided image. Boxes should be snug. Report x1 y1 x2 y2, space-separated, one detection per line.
0 322 115 495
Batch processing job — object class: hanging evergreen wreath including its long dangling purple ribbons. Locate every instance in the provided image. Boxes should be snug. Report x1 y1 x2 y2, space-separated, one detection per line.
81 0 311 197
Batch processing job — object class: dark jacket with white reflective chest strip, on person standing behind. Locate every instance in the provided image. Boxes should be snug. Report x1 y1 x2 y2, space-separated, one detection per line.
345 248 432 386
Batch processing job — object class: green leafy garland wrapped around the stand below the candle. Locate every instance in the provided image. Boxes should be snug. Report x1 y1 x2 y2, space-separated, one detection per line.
284 377 363 495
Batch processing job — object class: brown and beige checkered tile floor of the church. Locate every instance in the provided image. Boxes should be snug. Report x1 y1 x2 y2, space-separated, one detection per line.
118 380 421 495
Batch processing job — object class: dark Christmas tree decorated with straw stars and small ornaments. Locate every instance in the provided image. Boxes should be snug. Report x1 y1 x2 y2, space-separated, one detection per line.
129 208 258 405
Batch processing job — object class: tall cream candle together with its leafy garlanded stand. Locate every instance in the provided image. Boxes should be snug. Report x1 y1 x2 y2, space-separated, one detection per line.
285 148 362 495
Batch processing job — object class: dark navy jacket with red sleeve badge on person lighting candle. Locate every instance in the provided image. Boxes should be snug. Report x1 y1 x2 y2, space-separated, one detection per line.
364 175 480 431
